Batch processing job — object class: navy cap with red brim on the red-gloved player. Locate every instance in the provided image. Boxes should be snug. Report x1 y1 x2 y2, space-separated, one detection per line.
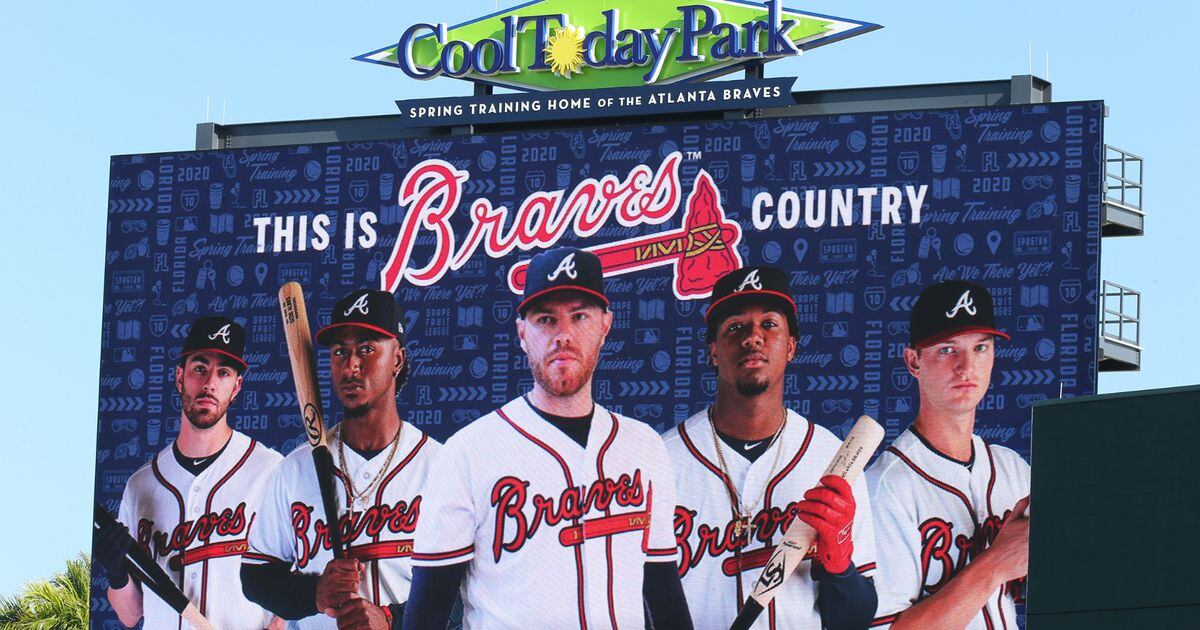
704 265 800 341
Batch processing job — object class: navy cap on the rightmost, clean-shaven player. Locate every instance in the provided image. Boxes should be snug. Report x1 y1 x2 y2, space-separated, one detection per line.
908 280 1012 348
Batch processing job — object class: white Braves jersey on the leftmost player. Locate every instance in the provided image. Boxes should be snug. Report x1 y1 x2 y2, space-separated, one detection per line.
118 431 282 630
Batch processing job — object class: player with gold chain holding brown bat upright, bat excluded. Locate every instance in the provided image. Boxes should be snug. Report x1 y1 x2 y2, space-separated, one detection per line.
241 289 438 629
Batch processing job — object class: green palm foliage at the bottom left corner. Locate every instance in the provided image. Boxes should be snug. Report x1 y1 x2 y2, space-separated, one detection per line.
0 553 91 630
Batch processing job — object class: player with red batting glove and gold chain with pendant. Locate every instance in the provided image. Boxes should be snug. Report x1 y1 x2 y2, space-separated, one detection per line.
664 266 876 629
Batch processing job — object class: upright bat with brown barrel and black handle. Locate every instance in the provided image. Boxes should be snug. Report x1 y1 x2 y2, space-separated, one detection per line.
280 282 346 558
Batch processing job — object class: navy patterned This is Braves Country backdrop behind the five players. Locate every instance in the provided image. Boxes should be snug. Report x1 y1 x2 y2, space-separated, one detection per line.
94 102 1103 628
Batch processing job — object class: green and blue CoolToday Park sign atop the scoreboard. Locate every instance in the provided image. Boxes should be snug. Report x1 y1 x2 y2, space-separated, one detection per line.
355 0 880 124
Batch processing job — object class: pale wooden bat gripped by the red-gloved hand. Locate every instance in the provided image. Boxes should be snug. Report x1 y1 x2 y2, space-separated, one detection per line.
730 415 883 630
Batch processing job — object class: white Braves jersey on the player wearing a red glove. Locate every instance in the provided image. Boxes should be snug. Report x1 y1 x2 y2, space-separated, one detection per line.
664 409 875 629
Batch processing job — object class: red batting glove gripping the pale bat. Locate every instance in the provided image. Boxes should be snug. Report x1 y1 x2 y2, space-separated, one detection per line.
799 475 854 575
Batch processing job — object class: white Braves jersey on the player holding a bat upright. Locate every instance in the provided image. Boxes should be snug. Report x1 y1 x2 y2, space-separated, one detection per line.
242 422 440 629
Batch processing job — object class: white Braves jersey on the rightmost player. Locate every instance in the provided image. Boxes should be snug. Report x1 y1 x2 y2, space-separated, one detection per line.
868 428 1030 630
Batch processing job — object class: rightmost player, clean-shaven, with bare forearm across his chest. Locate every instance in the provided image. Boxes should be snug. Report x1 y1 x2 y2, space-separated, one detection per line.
868 281 1030 630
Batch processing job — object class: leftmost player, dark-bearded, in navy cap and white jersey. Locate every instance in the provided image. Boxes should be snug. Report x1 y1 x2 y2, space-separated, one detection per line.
94 317 283 630
